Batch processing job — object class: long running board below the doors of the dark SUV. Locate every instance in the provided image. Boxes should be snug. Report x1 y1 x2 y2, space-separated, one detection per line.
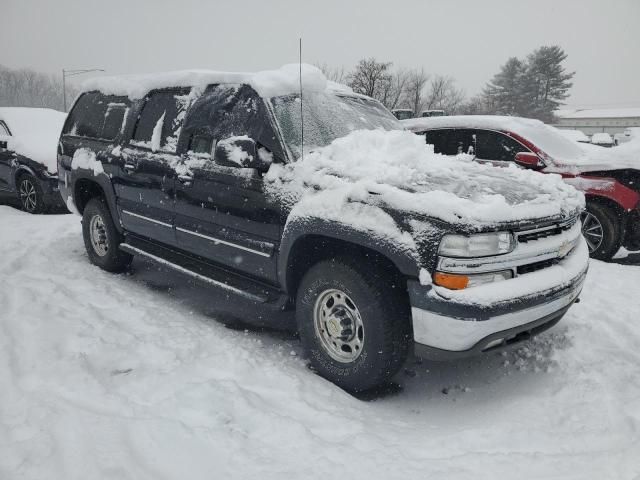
120 239 288 309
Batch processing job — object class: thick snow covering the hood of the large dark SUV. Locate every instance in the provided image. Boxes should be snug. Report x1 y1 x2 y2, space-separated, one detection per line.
265 130 584 234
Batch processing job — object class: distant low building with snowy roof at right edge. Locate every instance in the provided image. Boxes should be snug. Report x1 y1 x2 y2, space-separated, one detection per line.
555 107 640 135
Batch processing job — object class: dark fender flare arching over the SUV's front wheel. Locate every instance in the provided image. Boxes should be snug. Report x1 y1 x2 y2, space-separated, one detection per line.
278 217 420 289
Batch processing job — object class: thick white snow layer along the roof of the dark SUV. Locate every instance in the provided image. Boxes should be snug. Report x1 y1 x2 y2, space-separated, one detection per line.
82 64 352 99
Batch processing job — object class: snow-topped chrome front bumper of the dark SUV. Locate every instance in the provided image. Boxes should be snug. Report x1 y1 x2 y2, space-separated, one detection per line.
408 239 588 359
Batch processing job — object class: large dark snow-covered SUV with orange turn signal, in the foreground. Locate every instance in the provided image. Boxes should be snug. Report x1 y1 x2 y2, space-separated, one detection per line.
58 65 588 391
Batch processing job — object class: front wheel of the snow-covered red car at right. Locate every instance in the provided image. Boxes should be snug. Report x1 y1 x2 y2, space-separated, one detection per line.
582 202 623 260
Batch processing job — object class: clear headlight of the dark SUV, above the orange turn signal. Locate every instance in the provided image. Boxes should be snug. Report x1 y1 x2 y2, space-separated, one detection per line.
438 232 515 258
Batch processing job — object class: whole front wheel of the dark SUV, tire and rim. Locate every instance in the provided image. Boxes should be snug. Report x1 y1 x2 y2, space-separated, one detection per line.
296 259 411 392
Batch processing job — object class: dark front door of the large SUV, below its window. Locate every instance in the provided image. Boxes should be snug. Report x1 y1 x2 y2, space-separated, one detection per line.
175 160 281 281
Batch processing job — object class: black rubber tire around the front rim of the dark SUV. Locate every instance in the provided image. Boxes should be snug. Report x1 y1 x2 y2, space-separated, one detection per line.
296 259 411 392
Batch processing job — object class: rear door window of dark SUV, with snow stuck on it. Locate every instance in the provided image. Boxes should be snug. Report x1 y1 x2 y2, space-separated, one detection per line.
131 88 190 153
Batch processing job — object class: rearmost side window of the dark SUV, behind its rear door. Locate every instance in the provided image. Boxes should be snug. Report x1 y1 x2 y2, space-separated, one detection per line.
63 92 128 140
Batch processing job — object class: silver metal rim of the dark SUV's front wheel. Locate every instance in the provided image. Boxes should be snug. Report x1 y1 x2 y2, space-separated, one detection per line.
313 289 364 363
